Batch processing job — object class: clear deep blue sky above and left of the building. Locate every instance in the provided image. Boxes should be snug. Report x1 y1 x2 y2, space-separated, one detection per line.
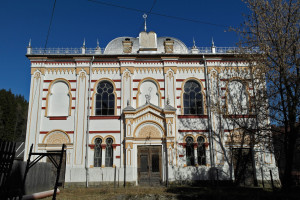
0 0 248 100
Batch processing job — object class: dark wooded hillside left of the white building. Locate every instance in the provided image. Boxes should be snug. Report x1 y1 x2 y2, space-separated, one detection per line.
0 89 28 142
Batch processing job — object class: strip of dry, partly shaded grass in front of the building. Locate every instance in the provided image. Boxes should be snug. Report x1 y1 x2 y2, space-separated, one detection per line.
46 186 300 200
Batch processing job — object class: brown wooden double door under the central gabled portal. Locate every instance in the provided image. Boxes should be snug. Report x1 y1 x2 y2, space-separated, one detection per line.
138 146 161 185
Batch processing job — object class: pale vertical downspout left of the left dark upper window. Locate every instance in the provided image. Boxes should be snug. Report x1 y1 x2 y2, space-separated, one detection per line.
85 56 95 187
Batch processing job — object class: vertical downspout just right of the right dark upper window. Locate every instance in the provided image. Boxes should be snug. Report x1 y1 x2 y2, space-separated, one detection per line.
203 55 215 172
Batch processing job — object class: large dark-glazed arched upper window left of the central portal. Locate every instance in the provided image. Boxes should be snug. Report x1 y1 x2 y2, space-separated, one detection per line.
95 81 115 115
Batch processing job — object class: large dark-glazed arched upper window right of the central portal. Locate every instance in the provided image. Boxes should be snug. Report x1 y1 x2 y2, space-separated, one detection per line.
183 81 203 115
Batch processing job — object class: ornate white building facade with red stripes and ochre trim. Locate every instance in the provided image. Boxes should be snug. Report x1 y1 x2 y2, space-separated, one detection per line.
24 29 278 184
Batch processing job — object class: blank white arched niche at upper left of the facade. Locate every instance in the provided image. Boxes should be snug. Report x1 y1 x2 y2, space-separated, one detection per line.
47 81 70 116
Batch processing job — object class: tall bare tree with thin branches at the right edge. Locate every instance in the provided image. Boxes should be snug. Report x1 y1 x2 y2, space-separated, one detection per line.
238 0 300 188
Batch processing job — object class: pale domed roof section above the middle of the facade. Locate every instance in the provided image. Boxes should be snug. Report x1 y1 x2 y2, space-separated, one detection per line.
104 32 188 54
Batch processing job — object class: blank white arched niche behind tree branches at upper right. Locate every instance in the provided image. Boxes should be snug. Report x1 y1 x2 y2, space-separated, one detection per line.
227 80 249 115
